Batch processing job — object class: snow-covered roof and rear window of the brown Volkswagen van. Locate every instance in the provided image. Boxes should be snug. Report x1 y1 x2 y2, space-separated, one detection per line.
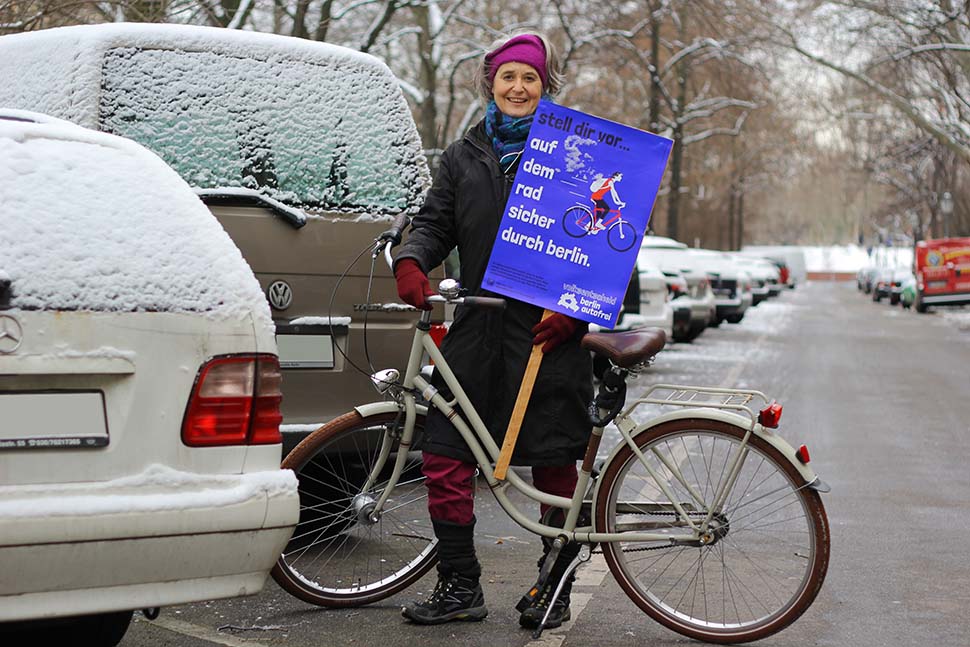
0 23 430 219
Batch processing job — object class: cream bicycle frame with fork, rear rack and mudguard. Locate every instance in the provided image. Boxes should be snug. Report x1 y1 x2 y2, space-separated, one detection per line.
363 302 824 543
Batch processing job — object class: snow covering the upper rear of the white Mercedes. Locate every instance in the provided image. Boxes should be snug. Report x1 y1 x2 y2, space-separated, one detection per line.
0 111 272 326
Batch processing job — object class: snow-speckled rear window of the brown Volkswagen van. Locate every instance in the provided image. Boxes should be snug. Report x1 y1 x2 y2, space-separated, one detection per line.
99 47 426 215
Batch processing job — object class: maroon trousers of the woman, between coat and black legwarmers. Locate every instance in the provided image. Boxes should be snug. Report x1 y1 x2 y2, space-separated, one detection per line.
421 452 578 525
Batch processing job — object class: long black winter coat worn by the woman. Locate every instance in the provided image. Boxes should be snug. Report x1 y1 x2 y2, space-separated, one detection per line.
397 122 593 466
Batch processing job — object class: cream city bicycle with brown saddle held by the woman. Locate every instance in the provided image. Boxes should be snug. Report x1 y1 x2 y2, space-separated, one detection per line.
273 223 829 643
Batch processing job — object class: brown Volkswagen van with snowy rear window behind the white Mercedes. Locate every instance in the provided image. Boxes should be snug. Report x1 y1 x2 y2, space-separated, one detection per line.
0 23 434 449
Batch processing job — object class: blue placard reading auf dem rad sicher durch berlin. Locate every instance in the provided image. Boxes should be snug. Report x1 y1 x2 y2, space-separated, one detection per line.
483 101 673 328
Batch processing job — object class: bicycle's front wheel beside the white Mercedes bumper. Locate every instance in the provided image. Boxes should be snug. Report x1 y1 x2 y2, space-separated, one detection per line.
272 411 438 607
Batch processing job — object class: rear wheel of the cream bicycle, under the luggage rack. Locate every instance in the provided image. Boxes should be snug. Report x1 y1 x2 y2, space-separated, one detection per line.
596 419 829 643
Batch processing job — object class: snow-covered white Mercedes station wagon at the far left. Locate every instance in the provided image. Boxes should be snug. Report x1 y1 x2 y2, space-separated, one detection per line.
0 110 299 645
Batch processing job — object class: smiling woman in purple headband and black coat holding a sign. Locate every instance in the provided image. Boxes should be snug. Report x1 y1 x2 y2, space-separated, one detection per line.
395 33 592 627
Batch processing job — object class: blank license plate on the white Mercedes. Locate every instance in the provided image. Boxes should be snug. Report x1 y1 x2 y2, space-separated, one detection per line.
0 391 108 449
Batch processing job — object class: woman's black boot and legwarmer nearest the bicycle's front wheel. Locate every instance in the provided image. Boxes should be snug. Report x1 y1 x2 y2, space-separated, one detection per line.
401 520 488 625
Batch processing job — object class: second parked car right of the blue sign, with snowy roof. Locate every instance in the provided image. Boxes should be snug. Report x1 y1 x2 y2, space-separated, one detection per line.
640 236 716 342
